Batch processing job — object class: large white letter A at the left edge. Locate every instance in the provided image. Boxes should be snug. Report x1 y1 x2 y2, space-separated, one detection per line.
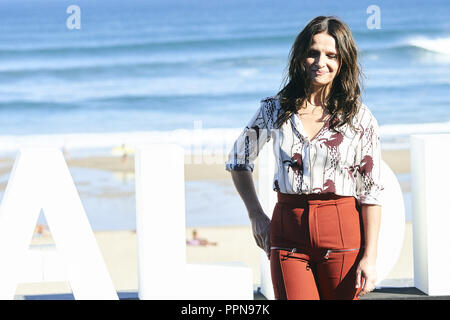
0 148 118 299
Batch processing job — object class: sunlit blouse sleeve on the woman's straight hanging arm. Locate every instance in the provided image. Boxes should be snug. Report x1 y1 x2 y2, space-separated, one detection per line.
355 109 384 205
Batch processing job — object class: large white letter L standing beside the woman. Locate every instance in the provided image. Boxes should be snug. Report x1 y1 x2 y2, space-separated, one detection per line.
135 144 253 300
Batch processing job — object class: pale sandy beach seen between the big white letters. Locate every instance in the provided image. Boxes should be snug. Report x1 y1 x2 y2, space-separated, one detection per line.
0 150 413 295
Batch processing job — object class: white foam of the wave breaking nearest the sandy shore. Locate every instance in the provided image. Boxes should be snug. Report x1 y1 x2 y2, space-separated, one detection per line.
0 121 450 154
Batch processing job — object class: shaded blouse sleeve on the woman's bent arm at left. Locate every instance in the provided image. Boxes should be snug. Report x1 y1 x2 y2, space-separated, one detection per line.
225 100 270 172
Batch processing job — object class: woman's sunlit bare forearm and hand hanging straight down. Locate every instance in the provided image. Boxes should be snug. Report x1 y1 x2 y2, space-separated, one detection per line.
356 205 381 296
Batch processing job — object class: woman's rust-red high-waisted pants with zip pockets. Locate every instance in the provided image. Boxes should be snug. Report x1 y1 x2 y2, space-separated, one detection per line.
270 192 364 300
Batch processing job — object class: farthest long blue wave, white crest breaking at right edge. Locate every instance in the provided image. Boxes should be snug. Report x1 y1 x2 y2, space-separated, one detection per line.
0 33 450 77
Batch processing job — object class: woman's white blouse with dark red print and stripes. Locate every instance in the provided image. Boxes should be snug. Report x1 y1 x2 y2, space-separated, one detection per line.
225 96 383 205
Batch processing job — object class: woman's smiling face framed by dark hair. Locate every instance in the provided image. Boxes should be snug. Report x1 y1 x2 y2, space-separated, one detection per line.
306 32 339 89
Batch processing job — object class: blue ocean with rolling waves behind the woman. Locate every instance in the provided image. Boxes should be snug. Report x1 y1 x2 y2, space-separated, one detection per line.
0 0 450 229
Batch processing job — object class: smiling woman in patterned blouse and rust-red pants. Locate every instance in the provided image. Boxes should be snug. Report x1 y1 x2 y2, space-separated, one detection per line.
226 16 384 300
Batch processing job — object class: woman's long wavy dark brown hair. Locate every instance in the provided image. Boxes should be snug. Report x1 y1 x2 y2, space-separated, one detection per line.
275 16 362 129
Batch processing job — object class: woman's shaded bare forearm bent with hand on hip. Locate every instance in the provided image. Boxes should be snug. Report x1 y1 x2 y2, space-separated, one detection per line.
231 170 270 256
